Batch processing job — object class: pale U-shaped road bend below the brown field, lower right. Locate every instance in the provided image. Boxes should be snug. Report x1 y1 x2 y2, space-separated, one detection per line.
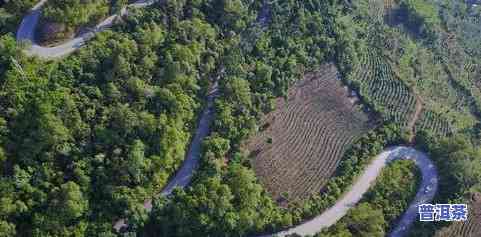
264 146 438 237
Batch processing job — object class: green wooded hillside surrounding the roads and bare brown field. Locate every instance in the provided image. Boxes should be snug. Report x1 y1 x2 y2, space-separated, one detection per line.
0 0 481 236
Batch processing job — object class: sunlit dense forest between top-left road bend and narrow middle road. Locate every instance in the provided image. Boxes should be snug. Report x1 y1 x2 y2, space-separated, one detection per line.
0 1 222 236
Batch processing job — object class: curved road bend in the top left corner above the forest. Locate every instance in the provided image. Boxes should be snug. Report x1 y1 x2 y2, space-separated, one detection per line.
17 0 156 59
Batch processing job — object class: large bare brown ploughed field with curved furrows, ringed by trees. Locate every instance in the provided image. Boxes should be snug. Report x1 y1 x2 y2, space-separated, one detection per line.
244 65 375 204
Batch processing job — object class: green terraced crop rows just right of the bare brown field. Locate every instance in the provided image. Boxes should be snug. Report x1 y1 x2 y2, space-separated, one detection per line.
351 51 416 127
